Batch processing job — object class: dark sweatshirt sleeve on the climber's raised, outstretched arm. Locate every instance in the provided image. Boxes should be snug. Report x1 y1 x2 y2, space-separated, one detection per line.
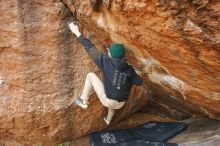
79 35 106 70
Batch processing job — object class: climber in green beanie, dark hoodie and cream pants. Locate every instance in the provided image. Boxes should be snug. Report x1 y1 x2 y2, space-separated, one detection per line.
69 22 142 125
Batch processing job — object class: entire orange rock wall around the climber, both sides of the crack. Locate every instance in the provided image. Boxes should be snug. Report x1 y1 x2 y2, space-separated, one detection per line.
0 0 220 144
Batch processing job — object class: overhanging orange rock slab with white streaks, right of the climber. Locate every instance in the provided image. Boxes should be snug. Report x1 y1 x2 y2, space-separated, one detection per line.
62 0 220 119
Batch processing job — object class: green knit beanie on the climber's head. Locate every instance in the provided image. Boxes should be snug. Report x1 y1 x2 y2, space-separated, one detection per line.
109 44 125 59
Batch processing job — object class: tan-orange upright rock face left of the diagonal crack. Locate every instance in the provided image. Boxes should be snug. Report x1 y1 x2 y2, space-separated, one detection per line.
0 0 147 145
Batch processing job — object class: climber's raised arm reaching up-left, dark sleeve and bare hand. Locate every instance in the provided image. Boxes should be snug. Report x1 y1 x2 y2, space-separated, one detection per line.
69 23 106 69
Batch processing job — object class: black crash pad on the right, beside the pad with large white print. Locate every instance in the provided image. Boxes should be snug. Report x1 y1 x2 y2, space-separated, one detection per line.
128 122 186 141
